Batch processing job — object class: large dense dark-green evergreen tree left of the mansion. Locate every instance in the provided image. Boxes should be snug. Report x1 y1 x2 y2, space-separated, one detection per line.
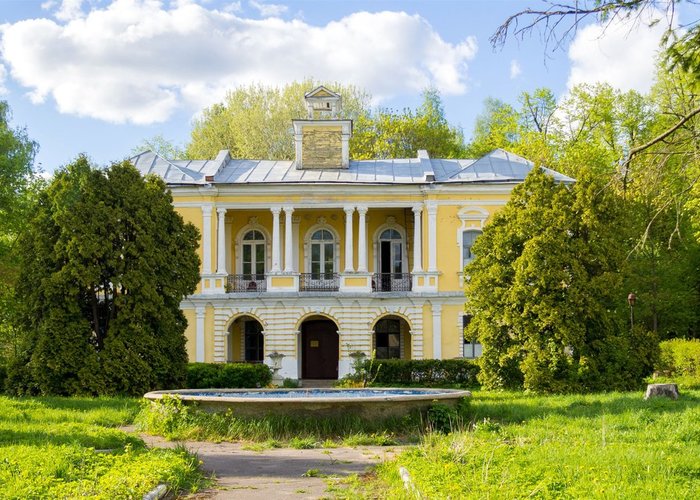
10 157 199 395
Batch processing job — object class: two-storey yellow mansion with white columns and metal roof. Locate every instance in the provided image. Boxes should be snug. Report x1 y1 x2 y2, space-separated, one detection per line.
132 87 571 379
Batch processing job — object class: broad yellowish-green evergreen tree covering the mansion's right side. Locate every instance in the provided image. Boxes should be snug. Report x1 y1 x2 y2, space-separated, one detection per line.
465 168 654 392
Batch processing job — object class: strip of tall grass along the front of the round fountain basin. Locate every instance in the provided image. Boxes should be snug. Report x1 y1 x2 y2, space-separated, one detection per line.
136 398 422 449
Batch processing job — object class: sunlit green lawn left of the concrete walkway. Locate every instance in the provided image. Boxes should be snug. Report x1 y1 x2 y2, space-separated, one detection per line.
0 396 208 499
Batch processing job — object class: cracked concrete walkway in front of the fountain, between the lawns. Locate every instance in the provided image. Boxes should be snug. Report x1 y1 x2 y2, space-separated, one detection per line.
140 434 402 500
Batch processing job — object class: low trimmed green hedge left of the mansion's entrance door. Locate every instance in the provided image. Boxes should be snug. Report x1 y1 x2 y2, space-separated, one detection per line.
187 363 272 389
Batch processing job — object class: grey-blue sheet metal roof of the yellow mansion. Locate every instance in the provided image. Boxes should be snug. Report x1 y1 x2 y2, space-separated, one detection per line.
131 149 574 185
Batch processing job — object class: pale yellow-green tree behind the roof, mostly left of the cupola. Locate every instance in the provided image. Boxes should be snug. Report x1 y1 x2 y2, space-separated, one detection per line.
186 80 369 160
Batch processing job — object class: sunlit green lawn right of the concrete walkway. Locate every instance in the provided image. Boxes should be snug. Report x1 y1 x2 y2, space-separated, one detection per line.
351 390 700 500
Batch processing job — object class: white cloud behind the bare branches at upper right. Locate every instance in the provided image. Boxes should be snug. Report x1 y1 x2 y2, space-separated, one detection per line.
567 11 667 92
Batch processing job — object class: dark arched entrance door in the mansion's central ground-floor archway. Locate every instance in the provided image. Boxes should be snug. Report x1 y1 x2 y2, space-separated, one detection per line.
301 319 338 379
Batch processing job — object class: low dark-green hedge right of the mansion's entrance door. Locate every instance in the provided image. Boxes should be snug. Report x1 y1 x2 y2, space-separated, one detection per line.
362 359 479 387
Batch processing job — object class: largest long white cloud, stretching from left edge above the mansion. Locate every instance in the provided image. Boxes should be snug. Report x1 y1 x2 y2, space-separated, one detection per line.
0 0 477 124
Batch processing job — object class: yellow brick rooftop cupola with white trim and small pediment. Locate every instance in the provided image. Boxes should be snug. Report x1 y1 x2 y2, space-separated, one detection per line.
292 85 352 169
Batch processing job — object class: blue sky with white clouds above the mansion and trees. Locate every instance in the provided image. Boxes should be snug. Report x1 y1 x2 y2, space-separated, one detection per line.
0 0 696 172
